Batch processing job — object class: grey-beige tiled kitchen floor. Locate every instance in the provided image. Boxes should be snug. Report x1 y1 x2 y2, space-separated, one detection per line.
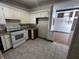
4 38 68 59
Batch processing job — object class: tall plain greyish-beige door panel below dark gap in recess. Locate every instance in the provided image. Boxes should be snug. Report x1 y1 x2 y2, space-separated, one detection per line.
38 19 48 39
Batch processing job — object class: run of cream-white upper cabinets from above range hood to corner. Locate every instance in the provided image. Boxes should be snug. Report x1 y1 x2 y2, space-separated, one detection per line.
4 8 30 23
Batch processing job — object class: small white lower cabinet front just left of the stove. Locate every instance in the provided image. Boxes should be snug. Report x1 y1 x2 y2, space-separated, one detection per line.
1 35 12 51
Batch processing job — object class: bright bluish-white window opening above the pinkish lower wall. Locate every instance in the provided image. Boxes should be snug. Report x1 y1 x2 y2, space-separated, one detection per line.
53 11 74 33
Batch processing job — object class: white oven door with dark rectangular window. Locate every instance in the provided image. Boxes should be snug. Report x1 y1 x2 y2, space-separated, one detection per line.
11 31 25 44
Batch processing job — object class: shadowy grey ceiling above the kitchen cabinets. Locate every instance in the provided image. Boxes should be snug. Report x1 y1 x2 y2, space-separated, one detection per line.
0 0 53 9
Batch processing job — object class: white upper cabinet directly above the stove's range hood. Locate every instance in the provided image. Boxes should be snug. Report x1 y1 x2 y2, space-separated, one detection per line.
4 8 20 19
